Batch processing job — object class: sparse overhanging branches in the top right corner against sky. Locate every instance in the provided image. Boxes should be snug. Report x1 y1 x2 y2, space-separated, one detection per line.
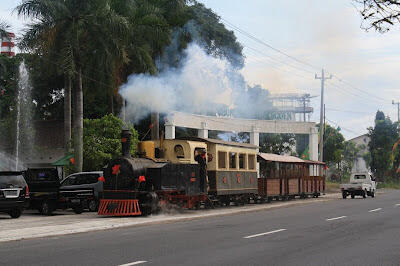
353 0 400 33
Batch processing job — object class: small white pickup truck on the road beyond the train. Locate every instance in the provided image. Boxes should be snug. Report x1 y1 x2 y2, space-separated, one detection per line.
340 172 376 199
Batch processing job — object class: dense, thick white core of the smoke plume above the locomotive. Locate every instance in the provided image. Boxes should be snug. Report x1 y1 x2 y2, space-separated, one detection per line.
120 43 246 120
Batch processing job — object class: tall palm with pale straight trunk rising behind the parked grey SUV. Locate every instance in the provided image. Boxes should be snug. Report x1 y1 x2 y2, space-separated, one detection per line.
16 0 128 171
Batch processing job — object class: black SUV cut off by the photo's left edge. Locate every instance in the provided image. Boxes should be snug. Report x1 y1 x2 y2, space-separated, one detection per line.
0 172 29 218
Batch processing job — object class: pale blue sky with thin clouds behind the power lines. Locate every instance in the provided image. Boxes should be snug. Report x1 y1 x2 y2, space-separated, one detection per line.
0 0 400 139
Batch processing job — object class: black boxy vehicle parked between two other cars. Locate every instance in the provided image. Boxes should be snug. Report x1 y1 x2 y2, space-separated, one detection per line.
24 168 93 215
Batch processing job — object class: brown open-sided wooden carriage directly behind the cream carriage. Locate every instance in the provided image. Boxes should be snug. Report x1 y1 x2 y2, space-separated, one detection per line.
257 153 306 200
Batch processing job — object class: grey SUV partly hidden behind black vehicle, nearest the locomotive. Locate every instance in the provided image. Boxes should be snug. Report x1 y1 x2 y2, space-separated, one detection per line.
60 171 103 211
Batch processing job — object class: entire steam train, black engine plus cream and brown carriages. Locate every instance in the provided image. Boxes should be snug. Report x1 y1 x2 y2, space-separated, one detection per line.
98 130 326 216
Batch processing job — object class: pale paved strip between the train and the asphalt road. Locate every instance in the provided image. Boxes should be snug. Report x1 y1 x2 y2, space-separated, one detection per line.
0 193 341 242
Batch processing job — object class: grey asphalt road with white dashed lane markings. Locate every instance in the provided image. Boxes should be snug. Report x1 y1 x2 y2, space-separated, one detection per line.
0 191 400 266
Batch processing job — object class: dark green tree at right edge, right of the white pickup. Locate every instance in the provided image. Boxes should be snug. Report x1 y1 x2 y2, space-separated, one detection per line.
368 111 399 180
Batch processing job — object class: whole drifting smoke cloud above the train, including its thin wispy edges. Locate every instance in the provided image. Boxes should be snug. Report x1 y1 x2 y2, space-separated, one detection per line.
120 34 269 122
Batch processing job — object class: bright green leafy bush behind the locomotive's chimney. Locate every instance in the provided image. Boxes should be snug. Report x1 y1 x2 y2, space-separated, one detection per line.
83 114 138 171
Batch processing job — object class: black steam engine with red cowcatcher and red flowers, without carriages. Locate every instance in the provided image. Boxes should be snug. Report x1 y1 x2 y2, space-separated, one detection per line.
98 130 207 216
